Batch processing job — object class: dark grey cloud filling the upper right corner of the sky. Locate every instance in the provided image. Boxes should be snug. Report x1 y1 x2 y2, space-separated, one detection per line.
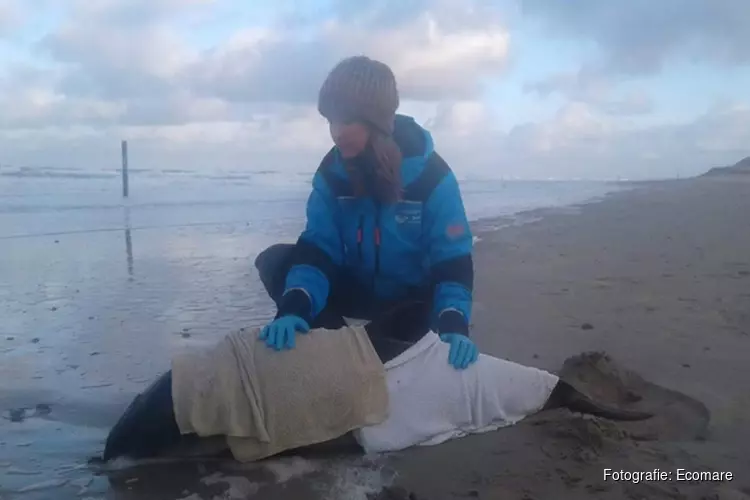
520 0 750 115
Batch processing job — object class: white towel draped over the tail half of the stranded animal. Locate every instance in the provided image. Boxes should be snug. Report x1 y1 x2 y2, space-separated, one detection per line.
354 332 559 453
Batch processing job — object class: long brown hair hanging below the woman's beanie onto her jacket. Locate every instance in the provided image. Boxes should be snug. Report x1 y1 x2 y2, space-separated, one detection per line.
347 129 403 204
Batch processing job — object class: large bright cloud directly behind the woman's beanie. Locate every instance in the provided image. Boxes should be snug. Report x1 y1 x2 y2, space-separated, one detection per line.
186 1 509 103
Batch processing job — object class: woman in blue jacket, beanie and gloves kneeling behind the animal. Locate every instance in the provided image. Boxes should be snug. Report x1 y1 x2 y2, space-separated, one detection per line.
255 56 479 369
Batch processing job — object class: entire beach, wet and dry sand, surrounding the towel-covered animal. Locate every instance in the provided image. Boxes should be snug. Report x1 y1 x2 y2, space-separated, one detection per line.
0 174 750 500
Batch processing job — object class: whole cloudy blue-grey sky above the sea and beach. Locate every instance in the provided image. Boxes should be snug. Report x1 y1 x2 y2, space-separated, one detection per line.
0 0 750 178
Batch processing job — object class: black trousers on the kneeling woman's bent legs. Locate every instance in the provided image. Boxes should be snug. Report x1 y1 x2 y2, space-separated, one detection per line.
255 243 432 342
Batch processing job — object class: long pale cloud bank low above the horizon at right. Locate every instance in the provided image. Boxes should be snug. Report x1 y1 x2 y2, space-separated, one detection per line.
488 103 750 178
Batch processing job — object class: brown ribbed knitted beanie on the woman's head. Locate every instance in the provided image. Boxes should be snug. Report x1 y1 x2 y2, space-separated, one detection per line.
318 56 399 135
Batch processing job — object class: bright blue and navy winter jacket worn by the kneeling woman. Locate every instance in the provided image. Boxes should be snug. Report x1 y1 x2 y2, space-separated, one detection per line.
279 115 474 335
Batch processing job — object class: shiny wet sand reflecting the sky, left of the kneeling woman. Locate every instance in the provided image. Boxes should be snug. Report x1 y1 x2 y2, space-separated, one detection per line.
0 203 284 500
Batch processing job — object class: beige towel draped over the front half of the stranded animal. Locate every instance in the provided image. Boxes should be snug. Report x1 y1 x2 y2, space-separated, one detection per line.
172 327 388 461
